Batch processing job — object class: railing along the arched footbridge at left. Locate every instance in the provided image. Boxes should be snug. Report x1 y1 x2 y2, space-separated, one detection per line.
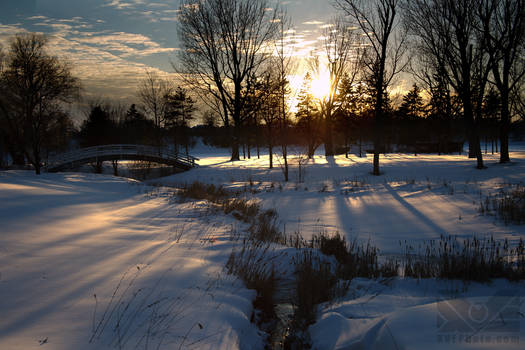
46 144 198 168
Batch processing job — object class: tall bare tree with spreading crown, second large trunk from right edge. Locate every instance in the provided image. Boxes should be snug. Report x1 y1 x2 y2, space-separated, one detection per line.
406 0 489 169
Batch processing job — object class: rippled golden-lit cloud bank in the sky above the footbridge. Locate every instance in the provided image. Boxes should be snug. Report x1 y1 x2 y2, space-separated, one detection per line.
0 18 177 101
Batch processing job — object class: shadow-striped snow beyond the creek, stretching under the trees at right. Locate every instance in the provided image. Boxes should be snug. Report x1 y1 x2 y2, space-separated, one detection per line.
162 144 525 254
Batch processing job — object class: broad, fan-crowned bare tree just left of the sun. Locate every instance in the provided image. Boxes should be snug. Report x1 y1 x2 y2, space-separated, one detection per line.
175 0 279 160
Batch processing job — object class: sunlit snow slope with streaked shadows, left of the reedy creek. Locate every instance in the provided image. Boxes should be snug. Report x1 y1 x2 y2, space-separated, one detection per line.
0 172 261 350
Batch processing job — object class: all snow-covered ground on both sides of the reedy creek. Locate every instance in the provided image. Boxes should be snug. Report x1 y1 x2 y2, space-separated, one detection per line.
0 145 525 349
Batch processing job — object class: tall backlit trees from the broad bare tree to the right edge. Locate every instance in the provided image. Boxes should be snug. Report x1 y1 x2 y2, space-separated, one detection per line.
177 0 525 178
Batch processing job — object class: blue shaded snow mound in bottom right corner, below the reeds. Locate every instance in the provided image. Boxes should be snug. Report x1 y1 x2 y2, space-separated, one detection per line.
310 278 525 349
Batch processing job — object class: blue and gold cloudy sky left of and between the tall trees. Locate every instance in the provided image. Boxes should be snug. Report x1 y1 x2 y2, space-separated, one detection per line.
0 0 335 111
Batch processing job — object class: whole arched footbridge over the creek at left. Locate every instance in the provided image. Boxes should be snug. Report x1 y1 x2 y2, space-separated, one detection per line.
45 145 198 172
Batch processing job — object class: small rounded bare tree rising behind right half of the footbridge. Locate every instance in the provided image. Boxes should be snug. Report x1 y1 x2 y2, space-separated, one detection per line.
138 71 174 148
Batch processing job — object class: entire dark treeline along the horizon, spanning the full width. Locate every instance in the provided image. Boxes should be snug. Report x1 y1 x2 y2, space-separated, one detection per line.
0 0 525 180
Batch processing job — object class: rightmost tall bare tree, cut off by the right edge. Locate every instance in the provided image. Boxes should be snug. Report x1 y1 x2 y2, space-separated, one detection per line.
479 0 525 163
